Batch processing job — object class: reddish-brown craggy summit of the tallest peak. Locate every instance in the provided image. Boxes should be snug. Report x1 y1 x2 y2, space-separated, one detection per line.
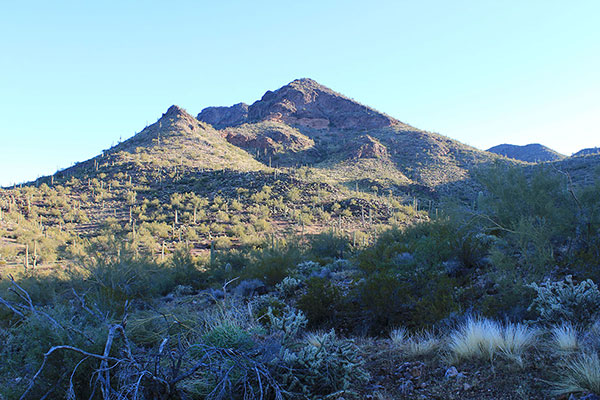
248 78 397 129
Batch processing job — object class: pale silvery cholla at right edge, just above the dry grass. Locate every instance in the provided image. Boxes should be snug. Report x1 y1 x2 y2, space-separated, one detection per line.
529 275 600 325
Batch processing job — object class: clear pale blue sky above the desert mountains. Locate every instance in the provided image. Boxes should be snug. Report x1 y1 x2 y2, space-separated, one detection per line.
0 0 600 185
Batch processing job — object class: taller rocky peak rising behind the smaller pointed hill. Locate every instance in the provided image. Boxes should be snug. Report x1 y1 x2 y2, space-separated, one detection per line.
197 78 496 193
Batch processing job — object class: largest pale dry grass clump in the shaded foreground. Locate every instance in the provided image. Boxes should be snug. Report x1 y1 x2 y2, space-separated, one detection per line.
448 318 537 364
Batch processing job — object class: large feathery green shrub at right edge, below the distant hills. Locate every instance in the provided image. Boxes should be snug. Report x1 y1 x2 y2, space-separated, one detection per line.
472 162 600 281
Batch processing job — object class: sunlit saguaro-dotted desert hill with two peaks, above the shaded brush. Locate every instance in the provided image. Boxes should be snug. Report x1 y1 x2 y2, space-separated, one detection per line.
2 79 499 266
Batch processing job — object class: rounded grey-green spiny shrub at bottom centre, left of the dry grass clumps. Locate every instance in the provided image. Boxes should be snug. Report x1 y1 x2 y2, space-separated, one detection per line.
282 330 369 398
